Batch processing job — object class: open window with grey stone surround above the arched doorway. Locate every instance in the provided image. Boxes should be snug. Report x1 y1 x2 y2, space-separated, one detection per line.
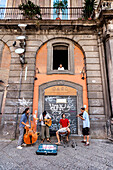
47 38 74 74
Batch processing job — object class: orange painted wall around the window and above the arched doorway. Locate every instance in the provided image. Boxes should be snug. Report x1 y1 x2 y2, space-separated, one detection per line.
33 43 88 119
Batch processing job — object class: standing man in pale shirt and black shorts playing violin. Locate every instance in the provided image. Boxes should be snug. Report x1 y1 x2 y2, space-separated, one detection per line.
77 108 90 146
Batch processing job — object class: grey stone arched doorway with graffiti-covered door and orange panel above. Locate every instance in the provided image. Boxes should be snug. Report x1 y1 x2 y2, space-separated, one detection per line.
38 80 83 134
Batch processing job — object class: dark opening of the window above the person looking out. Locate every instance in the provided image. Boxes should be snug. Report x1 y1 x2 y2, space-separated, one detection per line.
53 45 68 70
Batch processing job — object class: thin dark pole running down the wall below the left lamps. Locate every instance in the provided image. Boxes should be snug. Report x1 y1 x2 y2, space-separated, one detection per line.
15 64 23 139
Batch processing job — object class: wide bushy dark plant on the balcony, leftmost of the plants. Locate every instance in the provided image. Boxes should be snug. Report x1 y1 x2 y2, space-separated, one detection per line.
18 0 41 19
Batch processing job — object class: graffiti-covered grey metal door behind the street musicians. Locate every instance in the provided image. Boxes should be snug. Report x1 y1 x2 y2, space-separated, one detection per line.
44 96 77 134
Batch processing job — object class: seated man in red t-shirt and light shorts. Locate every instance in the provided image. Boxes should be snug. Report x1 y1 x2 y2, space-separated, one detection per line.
56 113 70 145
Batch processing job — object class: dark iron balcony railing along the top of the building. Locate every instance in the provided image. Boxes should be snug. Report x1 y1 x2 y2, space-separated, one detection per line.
0 7 83 20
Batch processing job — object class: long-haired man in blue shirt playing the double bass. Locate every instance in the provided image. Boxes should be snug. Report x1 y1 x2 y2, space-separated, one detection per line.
17 108 29 149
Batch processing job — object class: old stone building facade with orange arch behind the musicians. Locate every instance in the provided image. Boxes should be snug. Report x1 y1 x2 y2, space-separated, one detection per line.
0 0 112 138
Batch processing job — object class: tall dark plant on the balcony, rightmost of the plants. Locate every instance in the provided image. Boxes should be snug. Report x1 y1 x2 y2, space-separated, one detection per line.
83 0 97 20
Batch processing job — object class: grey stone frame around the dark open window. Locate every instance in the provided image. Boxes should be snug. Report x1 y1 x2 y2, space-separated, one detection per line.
47 39 75 74
